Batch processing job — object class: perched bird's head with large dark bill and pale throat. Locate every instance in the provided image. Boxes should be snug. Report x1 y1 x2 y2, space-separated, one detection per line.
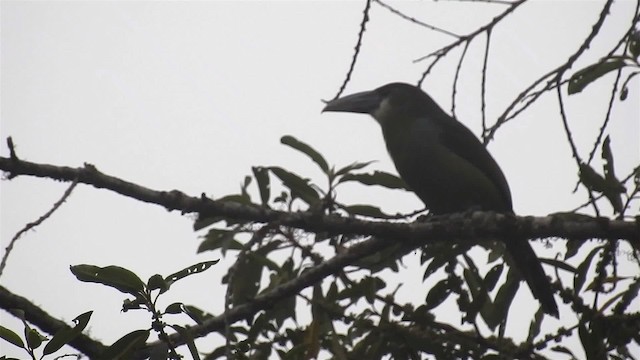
322 83 440 126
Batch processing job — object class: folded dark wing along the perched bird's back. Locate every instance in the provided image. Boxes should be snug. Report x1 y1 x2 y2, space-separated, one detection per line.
440 115 512 211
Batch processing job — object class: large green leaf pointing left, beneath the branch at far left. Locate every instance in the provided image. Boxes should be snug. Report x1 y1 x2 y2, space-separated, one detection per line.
70 264 145 295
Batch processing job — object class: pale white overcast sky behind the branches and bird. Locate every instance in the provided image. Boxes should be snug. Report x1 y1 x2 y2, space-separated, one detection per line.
0 1 640 356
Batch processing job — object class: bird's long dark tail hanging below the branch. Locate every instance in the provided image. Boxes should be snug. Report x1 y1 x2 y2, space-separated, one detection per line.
505 239 558 318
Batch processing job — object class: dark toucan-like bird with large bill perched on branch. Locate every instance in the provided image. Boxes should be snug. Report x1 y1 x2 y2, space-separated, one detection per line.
322 82 558 318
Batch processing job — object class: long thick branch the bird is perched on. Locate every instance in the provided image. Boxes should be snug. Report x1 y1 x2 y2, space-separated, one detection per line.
0 157 640 243
